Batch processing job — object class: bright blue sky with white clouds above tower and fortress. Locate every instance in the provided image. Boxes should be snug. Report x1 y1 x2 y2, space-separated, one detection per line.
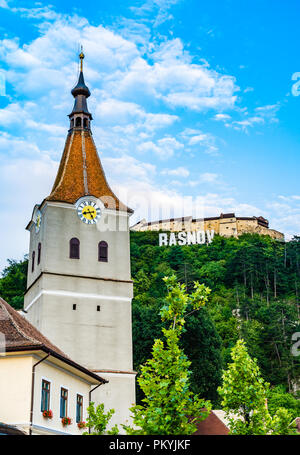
0 0 300 268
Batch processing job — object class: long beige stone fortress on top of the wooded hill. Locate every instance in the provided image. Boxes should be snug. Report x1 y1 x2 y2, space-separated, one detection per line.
131 213 284 240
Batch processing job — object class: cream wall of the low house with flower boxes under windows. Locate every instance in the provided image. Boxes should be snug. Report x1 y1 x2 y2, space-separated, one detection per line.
0 352 95 435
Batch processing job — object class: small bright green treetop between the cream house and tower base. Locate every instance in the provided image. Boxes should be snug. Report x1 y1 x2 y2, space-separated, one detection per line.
83 401 119 435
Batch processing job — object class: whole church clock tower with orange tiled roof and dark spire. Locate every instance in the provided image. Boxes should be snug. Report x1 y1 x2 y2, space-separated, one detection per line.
24 53 135 423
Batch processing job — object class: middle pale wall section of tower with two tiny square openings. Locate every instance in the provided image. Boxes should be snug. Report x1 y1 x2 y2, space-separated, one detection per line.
25 275 132 370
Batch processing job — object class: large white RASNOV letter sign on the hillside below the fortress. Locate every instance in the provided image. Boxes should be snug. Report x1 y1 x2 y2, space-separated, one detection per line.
158 230 215 246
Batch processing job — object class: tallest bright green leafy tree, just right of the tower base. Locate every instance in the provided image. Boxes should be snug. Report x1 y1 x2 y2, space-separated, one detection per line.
123 275 211 435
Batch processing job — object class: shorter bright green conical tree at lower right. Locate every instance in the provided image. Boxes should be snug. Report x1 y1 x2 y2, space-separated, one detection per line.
218 340 296 435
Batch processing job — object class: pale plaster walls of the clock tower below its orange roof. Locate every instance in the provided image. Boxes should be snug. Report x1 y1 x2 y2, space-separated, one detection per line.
24 203 135 430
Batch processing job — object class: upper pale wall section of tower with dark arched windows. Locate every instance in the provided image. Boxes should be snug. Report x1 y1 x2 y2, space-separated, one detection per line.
28 203 130 286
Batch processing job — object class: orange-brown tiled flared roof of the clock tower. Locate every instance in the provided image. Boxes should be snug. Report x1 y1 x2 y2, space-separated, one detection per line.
46 129 132 213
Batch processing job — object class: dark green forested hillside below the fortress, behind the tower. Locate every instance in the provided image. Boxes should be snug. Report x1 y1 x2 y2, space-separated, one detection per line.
0 232 300 415
